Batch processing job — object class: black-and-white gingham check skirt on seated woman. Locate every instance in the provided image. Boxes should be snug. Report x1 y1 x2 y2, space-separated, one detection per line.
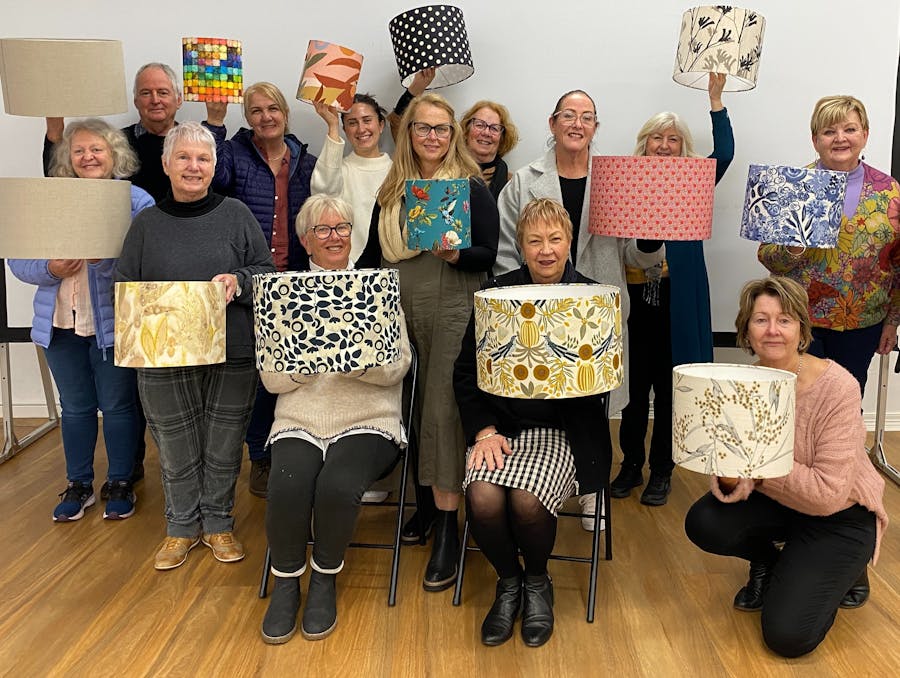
463 428 576 516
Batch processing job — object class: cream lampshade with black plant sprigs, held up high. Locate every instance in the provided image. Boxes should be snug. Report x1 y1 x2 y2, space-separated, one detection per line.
672 5 766 92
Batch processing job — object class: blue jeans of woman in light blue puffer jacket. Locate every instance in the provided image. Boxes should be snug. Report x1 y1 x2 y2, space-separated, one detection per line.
44 329 137 483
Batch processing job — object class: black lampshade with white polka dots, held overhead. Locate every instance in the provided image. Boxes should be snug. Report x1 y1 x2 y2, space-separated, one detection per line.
388 5 475 89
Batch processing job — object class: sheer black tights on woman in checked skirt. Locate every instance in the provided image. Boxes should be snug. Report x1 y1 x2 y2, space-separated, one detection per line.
466 480 556 579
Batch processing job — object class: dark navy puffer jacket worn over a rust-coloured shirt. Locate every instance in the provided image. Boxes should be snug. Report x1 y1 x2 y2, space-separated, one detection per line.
203 122 316 271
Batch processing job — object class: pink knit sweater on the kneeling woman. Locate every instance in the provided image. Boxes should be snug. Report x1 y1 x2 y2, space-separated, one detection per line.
758 360 888 564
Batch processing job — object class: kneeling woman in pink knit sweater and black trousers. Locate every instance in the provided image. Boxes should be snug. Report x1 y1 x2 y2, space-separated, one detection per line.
684 277 888 657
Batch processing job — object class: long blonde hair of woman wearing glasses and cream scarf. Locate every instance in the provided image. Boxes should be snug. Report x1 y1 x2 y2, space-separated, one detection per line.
378 92 481 208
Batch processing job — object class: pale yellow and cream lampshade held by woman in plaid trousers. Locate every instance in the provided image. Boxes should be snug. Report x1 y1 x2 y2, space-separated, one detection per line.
116 281 225 367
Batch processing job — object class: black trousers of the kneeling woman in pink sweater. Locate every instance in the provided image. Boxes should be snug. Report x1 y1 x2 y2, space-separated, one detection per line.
684 492 875 657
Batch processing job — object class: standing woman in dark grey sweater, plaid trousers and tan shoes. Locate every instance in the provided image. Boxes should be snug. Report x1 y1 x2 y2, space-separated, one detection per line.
116 122 275 570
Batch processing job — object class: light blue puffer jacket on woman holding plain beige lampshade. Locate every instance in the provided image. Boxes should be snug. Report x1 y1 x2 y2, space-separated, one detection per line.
7 185 154 349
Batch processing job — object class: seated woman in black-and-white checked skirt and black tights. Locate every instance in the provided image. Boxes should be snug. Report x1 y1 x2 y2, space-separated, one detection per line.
453 198 612 647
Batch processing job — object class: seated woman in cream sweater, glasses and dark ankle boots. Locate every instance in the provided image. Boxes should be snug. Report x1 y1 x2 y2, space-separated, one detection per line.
261 194 410 644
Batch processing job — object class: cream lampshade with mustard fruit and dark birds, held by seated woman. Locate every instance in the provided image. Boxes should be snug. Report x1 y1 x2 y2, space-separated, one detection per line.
475 284 624 399
